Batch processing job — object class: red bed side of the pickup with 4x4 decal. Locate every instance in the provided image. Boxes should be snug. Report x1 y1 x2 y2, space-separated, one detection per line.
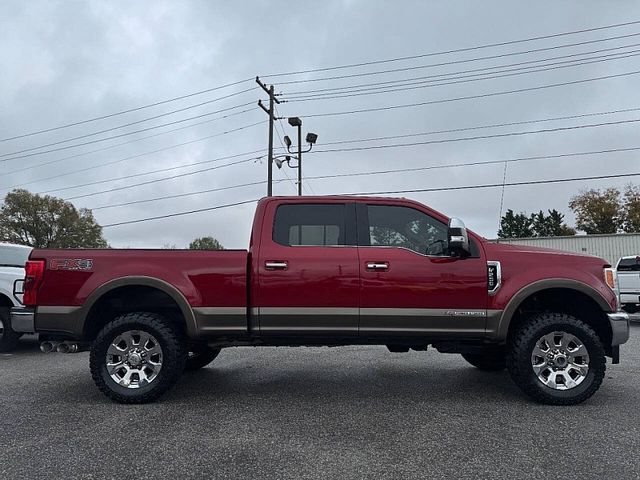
30 249 248 336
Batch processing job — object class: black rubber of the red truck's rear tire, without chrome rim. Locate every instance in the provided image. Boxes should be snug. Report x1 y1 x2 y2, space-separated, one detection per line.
90 312 187 404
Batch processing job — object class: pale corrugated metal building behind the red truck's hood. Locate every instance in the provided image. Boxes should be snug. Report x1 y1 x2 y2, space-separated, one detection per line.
497 233 640 266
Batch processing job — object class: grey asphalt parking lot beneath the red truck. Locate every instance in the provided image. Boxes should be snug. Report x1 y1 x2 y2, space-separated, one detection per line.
0 325 640 479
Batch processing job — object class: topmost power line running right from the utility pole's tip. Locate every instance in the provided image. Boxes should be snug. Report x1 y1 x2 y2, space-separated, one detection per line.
264 20 640 77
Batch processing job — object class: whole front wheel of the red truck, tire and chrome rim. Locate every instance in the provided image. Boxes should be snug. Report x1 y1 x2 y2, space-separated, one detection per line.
507 313 606 405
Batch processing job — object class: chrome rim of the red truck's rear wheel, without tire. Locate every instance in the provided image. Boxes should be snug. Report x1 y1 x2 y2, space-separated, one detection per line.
106 330 162 388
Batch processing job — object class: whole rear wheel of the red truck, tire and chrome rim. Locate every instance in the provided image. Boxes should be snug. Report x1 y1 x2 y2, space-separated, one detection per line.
90 312 187 403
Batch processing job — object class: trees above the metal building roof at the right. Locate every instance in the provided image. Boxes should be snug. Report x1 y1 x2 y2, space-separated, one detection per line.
498 185 640 238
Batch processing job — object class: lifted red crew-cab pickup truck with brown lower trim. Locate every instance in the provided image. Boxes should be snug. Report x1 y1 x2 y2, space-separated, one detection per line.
11 196 629 405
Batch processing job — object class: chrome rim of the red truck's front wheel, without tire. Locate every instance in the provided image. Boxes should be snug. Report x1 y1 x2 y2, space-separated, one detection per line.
531 332 589 390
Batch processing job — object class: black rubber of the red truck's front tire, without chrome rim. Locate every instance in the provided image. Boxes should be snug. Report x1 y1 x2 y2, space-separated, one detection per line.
507 313 606 405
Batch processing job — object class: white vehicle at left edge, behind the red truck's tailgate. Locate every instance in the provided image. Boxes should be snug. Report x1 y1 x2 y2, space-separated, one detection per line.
0 243 31 352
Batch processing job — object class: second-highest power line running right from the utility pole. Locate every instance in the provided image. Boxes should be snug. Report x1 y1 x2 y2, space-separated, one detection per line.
270 33 640 85
